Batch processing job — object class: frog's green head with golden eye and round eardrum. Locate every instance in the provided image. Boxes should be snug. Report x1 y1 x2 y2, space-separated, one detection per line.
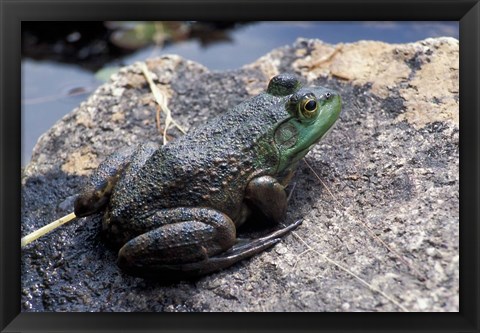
267 76 341 172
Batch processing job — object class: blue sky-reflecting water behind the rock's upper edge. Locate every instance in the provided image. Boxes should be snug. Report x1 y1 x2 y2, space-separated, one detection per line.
22 22 459 166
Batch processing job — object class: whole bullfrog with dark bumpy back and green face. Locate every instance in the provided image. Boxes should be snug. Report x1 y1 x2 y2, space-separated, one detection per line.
74 74 341 279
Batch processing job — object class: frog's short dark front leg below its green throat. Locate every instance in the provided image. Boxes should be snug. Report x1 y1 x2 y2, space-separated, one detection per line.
245 176 287 223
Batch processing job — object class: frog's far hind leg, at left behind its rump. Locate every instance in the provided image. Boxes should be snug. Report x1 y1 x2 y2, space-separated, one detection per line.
74 142 158 217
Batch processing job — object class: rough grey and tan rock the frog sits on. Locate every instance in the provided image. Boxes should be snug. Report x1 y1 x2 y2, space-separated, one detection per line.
22 38 459 312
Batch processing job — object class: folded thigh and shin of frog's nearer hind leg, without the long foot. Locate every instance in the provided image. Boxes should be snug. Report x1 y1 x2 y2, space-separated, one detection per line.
118 207 236 280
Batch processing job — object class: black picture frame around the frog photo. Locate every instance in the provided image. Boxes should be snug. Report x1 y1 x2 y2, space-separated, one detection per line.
0 0 480 332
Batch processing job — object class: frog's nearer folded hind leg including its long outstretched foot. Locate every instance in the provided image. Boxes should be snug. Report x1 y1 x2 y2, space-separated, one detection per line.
118 208 301 281
